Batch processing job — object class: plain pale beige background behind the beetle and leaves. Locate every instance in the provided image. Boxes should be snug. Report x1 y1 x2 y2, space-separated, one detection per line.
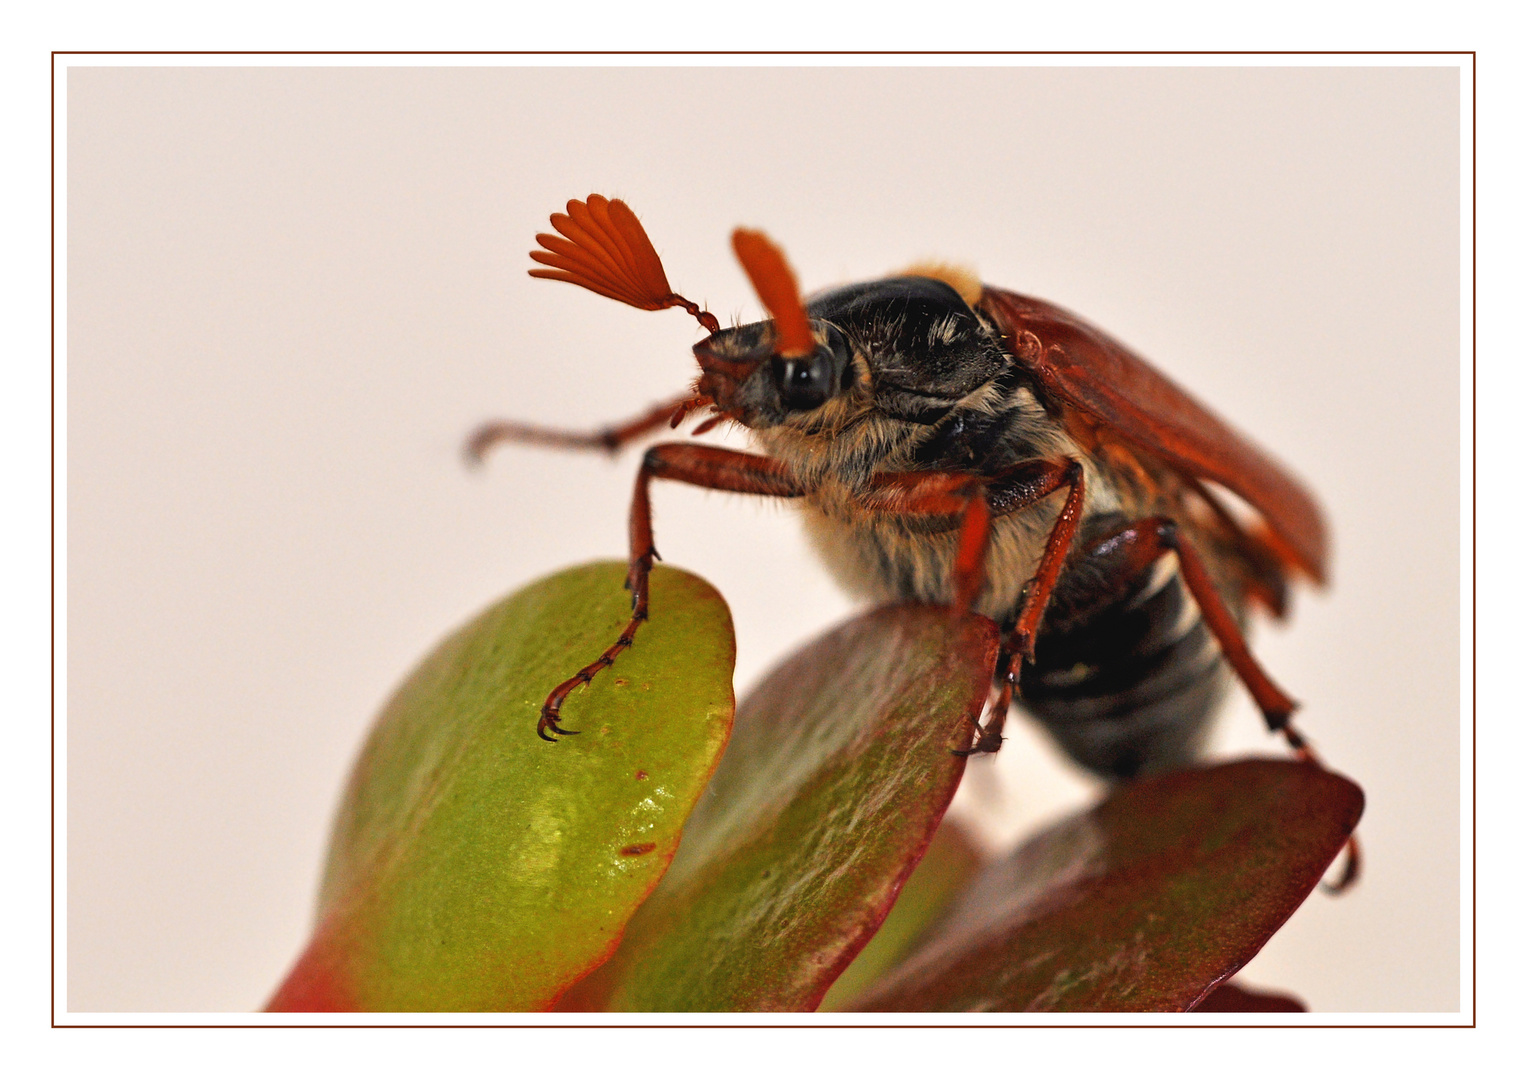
66 67 1460 1011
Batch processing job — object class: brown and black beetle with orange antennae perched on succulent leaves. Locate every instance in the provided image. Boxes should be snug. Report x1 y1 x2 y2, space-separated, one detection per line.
467 196 1331 788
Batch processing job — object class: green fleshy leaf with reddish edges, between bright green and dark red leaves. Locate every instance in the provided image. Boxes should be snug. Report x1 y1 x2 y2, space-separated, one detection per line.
560 606 997 1011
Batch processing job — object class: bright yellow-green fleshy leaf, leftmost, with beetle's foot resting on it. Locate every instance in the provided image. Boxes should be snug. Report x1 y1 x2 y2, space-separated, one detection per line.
267 562 734 1011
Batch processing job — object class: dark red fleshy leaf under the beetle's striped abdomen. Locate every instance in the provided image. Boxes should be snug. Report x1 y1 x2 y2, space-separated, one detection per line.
855 761 1362 1013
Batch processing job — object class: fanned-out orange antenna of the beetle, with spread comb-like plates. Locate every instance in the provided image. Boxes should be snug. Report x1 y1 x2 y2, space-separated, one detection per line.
530 196 721 333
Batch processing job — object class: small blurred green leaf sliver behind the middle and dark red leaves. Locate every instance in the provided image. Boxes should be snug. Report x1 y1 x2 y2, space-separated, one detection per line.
817 817 982 1013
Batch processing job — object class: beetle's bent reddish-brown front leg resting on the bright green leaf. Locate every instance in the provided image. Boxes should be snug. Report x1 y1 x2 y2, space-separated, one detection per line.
536 443 803 742
